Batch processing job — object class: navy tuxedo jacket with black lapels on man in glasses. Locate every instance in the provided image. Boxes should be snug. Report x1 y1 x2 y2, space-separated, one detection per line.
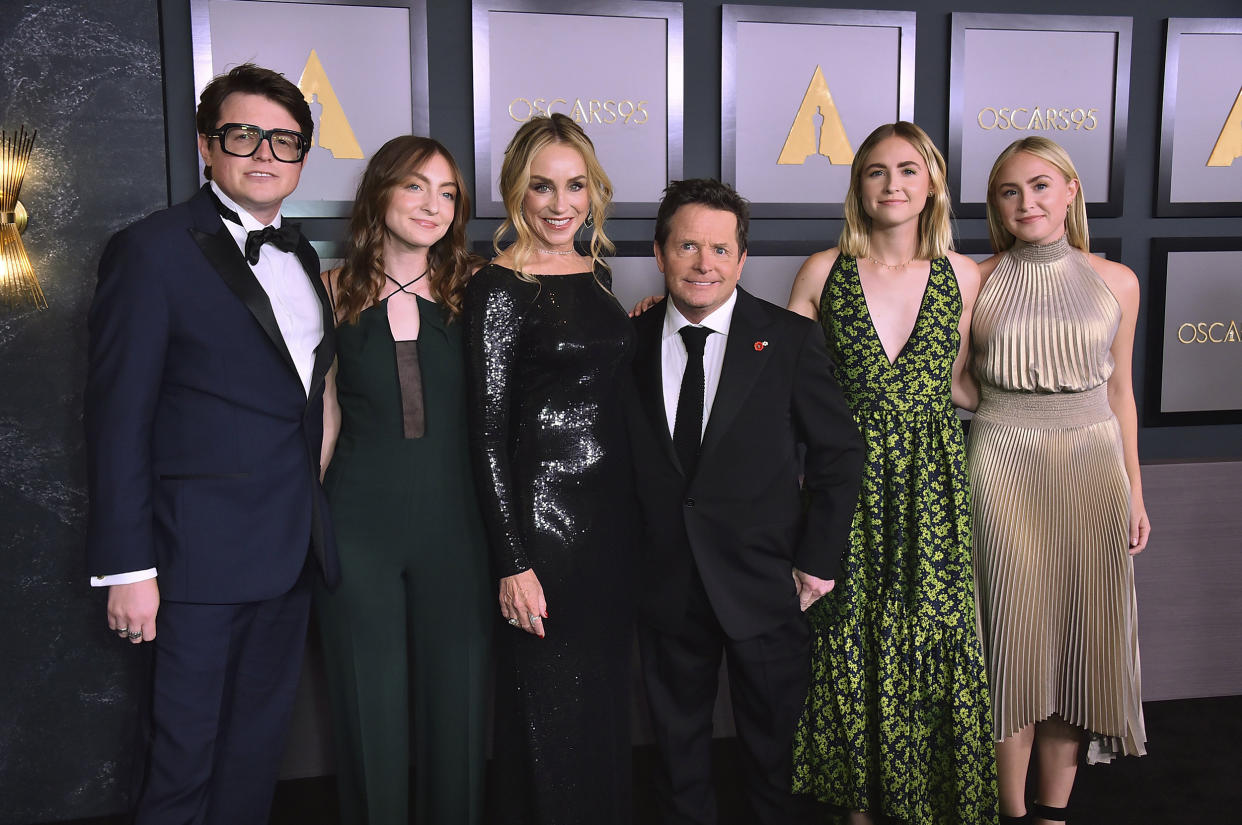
84 186 338 604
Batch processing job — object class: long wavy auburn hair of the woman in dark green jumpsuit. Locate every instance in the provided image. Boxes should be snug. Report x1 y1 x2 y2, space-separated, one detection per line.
337 134 482 323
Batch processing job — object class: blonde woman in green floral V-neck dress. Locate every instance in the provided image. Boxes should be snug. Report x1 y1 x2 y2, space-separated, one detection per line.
790 122 997 825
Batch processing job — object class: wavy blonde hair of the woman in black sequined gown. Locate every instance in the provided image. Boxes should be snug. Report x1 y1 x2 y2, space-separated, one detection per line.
492 112 615 282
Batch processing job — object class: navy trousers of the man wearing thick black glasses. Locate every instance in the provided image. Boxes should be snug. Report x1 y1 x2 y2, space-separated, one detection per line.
135 570 311 825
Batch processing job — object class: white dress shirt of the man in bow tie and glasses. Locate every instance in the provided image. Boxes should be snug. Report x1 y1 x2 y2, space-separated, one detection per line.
91 181 325 588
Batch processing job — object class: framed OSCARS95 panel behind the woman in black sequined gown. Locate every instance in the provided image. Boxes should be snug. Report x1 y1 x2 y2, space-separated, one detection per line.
473 0 683 217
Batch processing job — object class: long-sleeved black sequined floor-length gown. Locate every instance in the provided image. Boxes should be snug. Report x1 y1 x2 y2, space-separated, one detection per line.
465 263 633 825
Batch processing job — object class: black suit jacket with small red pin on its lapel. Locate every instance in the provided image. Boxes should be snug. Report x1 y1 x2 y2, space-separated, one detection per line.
628 288 863 640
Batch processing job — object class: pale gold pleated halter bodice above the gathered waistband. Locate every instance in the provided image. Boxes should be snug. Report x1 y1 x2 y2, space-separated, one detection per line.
971 237 1122 393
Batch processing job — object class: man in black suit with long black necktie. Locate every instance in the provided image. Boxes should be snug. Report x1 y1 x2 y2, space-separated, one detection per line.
630 180 862 825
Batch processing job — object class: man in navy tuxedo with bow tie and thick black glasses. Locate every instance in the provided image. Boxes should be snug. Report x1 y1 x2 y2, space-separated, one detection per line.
84 65 338 825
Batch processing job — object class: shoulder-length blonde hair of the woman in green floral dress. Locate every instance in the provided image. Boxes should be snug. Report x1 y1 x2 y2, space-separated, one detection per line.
837 121 953 260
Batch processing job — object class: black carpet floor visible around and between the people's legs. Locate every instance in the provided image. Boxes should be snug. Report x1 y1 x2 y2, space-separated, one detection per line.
38 696 1242 825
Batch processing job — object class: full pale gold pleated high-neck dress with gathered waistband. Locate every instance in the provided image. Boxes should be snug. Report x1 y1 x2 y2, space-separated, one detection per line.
966 233 1146 762
